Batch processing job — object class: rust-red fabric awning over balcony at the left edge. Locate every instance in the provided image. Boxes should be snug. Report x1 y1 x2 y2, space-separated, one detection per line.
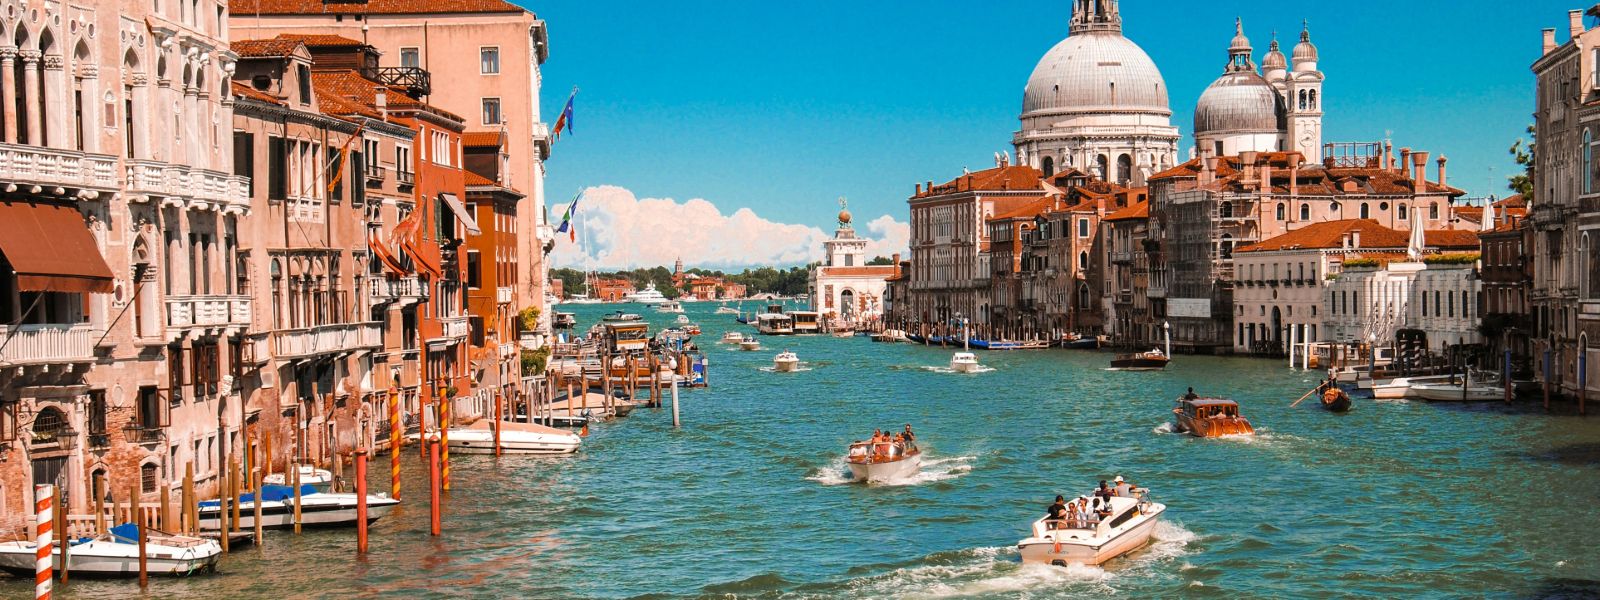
0 200 112 293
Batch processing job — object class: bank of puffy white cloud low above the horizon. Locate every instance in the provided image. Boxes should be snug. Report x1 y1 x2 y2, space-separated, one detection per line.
552 186 910 269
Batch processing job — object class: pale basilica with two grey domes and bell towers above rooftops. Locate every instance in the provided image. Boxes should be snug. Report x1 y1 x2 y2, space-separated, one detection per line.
1011 0 1323 186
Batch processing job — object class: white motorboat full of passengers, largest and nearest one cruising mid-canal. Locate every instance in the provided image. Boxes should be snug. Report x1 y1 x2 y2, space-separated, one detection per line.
1016 496 1166 566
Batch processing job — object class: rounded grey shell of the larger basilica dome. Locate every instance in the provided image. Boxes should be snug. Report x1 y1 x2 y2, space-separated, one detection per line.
1022 30 1171 117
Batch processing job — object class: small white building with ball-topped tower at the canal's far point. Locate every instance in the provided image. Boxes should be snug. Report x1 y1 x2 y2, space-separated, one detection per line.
806 200 899 326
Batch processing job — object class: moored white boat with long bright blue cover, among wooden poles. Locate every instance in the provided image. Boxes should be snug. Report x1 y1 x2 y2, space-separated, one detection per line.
198 485 400 530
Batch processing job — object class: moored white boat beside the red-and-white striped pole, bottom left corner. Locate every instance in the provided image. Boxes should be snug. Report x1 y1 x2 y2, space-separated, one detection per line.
0 523 222 578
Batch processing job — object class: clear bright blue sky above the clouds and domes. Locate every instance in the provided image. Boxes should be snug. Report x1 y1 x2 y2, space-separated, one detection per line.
520 0 1586 265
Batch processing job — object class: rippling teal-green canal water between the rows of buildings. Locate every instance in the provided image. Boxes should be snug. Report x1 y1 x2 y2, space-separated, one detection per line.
25 302 1600 598
